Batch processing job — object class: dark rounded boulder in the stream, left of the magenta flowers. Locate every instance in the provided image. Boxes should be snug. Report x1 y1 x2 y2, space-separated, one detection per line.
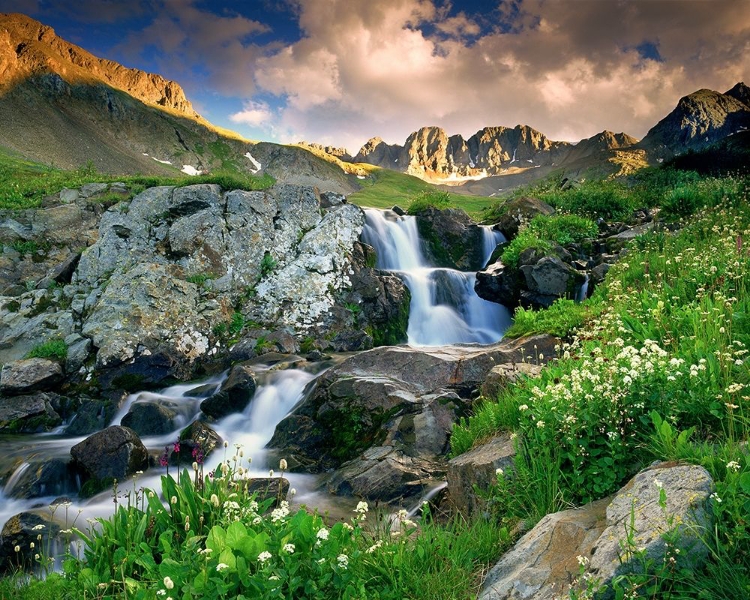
70 425 148 480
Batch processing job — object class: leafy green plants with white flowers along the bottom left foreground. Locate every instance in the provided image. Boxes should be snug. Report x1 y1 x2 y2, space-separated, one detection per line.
0 458 509 600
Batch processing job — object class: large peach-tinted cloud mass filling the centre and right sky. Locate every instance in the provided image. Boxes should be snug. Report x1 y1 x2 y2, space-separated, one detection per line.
242 0 750 151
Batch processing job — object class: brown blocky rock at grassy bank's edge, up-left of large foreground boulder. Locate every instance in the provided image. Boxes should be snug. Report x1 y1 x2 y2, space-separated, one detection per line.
447 434 516 516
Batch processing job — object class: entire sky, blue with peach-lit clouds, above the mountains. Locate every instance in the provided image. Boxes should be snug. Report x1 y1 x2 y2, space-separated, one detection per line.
0 0 750 153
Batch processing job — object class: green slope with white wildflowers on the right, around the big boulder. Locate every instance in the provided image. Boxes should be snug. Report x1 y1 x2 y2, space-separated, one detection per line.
452 173 750 598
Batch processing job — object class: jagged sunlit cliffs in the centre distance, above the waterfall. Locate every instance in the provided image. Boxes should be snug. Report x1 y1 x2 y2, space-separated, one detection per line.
353 125 572 179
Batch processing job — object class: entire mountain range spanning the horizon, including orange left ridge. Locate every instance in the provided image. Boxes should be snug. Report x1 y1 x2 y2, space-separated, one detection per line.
0 14 750 195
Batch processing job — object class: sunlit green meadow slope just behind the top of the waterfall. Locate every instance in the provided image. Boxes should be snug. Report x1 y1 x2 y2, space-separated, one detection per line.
348 165 497 219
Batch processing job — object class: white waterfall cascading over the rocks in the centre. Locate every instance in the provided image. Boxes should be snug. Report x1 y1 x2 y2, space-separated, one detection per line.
362 209 511 346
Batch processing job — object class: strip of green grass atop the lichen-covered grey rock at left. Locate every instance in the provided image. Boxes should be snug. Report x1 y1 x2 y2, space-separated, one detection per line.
0 148 274 209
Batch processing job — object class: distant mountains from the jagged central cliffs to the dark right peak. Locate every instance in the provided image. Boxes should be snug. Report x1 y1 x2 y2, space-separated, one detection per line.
351 83 750 182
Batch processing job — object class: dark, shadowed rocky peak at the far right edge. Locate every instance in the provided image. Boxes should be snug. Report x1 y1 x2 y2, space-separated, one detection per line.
640 83 750 159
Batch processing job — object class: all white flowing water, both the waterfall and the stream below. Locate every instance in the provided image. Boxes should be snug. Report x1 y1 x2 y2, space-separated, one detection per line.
0 210 510 540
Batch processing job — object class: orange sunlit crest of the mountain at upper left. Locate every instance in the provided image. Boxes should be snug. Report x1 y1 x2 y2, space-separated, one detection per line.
0 13 198 117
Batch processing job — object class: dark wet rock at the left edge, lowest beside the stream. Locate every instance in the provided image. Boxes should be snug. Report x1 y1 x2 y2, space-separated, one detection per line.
0 512 60 573
